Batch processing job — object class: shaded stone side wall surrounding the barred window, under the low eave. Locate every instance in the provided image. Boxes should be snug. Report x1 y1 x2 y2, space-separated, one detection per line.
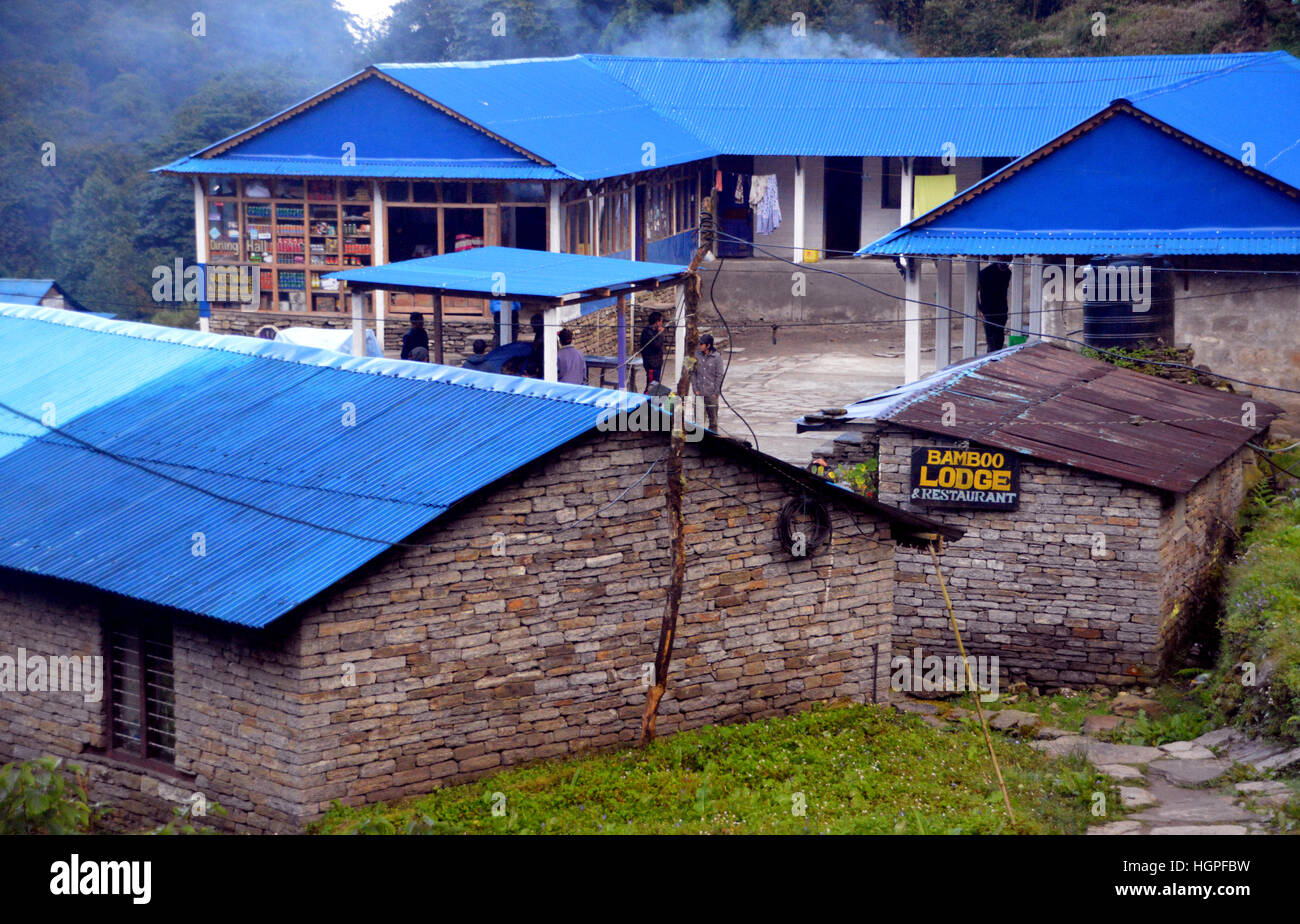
0 576 299 833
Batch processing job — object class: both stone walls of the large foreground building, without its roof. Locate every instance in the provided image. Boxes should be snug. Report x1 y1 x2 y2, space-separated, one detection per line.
0 434 893 832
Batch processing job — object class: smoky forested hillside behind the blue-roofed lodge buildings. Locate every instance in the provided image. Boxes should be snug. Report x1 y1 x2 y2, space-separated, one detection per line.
0 0 1300 322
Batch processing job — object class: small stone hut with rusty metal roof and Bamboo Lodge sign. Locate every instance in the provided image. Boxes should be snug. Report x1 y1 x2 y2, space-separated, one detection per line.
803 343 1278 687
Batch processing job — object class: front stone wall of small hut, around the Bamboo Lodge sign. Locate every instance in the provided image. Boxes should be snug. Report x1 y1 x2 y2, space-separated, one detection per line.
863 428 1166 687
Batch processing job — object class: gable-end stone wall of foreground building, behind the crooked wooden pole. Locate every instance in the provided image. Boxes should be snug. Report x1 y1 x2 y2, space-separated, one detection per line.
287 434 892 816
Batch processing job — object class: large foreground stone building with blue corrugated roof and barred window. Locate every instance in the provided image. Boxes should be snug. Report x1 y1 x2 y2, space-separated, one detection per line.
0 305 959 832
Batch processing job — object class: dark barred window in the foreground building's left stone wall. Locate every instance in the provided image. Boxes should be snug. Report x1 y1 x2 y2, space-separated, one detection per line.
104 619 176 764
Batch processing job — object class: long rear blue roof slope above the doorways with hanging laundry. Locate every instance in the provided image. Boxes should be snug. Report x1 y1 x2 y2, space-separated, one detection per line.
588 52 1274 157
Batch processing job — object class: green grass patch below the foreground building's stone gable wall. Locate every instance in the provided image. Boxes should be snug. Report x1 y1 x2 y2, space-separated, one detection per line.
313 706 1119 834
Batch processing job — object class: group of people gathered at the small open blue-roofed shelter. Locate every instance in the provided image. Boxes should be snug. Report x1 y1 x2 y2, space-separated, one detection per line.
402 311 727 430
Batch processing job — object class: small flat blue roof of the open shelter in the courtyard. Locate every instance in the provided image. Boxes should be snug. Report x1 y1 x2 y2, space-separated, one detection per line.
325 247 686 300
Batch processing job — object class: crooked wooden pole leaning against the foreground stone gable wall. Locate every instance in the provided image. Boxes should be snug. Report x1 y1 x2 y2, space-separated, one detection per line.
641 247 707 745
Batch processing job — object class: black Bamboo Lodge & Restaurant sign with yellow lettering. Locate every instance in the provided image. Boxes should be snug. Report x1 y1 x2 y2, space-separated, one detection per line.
910 446 1021 511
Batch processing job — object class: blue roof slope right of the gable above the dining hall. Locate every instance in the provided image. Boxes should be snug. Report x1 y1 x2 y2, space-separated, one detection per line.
378 56 716 179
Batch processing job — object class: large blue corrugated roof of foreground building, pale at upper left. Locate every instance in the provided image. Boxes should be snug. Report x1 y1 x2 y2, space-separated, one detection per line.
0 305 646 626
